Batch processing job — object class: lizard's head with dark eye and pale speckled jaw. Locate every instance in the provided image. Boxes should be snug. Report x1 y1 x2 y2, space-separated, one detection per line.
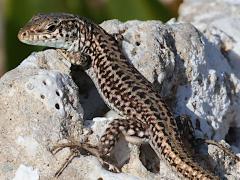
18 13 83 51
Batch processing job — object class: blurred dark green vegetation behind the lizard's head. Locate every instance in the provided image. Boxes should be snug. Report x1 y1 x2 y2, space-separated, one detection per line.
5 0 173 70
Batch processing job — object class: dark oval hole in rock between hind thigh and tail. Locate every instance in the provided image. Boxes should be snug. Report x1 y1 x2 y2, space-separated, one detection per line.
139 144 160 173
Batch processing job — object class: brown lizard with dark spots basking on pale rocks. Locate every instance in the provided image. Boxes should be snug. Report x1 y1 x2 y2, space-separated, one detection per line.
18 13 232 180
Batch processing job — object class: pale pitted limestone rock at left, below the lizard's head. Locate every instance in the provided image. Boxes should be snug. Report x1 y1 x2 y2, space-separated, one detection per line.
0 50 83 179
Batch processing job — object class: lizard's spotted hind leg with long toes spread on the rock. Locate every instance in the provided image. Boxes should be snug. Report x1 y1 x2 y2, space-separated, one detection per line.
50 119 148 177
